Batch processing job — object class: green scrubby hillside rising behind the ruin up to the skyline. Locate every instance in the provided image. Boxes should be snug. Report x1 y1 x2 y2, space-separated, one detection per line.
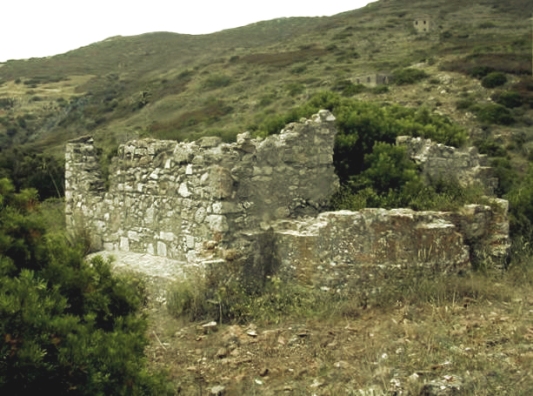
0 0 533 162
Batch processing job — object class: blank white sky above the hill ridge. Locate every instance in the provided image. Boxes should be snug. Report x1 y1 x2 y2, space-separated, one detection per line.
0 0 372 62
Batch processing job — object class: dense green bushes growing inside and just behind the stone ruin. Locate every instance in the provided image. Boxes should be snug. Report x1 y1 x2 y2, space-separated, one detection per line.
252 92 475 210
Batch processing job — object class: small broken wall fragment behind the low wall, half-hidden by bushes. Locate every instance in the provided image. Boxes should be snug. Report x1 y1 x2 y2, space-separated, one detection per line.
396 136 498 195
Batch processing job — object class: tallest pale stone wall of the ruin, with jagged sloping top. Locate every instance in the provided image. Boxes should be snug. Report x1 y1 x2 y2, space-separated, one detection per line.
66 111 338 262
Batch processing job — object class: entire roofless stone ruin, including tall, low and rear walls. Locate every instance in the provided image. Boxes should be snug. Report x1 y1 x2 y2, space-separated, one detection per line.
65 110 509 287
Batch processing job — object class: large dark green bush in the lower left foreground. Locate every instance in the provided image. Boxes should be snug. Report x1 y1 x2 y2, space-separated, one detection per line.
0 179 167 395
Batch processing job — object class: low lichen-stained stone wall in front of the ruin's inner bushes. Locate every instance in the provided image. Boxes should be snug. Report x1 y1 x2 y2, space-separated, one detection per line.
273 200 509 288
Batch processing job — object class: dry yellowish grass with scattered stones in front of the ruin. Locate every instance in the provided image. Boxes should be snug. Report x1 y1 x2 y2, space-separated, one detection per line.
148 263 533 395
